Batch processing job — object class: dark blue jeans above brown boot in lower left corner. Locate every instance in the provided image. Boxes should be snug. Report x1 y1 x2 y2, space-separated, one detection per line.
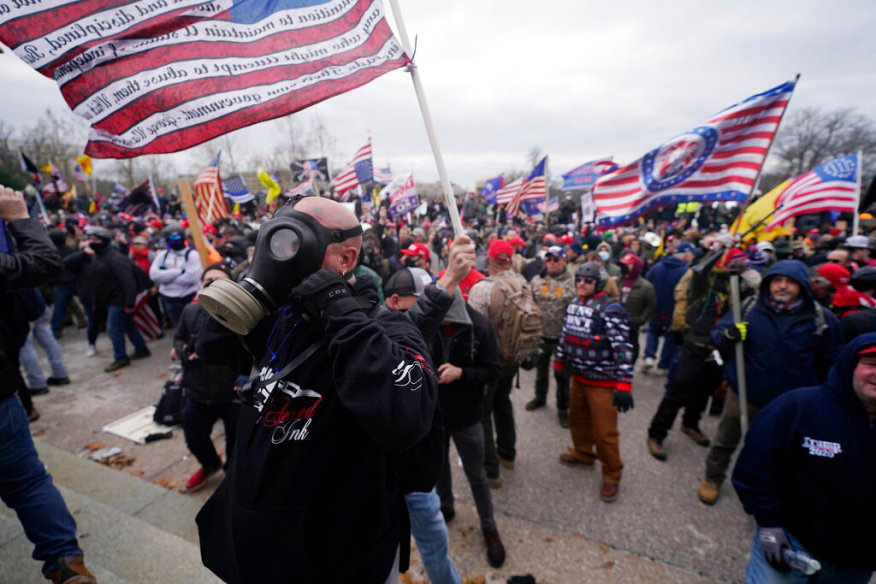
0 396 82 574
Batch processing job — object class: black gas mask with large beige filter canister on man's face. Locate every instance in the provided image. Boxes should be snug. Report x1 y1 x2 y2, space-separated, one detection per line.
199 201 362 335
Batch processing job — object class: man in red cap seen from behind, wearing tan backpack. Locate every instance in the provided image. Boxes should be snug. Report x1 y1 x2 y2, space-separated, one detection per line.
468 239 541 488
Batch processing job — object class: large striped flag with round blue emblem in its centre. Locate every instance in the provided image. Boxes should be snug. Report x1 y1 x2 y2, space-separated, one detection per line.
593 81 795 226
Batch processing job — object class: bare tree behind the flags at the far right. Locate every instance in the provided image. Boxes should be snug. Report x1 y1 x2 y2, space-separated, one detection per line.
772 108 876 177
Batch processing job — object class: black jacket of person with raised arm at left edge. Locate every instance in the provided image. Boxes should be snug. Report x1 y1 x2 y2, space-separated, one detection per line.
0 219 61 400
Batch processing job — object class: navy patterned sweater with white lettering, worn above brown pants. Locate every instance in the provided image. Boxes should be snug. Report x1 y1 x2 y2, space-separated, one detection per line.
554 292 633 391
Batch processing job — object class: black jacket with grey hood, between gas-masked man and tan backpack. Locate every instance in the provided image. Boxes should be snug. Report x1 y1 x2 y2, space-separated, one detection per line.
438 304 499 432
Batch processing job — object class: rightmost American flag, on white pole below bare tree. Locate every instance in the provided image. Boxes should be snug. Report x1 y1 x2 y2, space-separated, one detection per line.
767 154 860 229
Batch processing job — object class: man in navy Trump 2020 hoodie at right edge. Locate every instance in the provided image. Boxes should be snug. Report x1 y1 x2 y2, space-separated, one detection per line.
733 333 876 584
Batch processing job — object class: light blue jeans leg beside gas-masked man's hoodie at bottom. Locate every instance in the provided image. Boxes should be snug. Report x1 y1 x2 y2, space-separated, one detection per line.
405 489 460 584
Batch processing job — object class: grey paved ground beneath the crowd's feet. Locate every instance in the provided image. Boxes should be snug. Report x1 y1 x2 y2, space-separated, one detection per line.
20 329 750 583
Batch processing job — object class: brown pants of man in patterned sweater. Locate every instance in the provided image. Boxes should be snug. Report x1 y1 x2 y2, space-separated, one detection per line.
569 378 624 483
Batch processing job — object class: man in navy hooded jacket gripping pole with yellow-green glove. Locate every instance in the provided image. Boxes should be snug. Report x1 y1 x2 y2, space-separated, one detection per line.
699 260 842 505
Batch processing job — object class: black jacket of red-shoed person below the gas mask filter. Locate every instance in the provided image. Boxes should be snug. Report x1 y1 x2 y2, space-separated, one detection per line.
173 302 239 404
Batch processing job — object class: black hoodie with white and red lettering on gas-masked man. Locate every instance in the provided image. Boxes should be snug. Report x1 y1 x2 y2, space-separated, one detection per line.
195 296 437 583
